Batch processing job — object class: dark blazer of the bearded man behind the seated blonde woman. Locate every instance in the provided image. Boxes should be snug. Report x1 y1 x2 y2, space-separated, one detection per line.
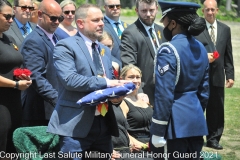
120 19 165 105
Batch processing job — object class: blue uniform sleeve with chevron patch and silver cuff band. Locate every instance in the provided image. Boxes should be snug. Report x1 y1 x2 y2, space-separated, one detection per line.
150 47 177 137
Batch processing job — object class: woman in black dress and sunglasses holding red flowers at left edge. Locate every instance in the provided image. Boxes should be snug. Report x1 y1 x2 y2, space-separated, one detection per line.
0 0 32 154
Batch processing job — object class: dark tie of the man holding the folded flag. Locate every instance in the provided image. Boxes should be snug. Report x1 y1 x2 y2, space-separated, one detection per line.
92 42 103 76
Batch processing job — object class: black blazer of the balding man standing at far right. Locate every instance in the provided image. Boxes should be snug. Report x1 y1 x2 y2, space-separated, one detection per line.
196 21 234 87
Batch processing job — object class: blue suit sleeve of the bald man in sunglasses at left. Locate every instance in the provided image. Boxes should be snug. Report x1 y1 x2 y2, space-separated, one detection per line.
20 39 58 105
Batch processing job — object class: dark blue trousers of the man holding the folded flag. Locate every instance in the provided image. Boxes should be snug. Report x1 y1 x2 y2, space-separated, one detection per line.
58 115 113 160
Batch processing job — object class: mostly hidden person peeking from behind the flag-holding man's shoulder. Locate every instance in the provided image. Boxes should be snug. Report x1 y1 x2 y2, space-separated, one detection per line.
98 31 120 79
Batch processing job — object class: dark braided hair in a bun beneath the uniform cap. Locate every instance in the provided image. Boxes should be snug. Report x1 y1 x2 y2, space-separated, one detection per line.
166 12 206 36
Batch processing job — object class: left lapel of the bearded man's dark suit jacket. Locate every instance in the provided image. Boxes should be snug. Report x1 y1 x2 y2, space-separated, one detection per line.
136 19 155 58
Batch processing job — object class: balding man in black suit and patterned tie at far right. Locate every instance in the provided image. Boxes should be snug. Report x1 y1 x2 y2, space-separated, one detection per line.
196 0 234 149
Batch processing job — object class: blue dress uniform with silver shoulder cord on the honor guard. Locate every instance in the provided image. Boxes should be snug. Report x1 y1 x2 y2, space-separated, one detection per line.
150 2 209 159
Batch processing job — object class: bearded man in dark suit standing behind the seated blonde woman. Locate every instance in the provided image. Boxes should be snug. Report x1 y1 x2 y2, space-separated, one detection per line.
120 0 163 105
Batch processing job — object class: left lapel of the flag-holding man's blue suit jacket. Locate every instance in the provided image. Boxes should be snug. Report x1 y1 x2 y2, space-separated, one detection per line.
75 33 97 76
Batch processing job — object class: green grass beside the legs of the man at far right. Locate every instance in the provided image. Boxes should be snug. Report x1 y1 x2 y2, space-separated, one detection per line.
203 88 240 160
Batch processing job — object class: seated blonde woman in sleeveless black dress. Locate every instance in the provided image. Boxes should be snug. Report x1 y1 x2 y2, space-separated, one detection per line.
112 64 153 160
